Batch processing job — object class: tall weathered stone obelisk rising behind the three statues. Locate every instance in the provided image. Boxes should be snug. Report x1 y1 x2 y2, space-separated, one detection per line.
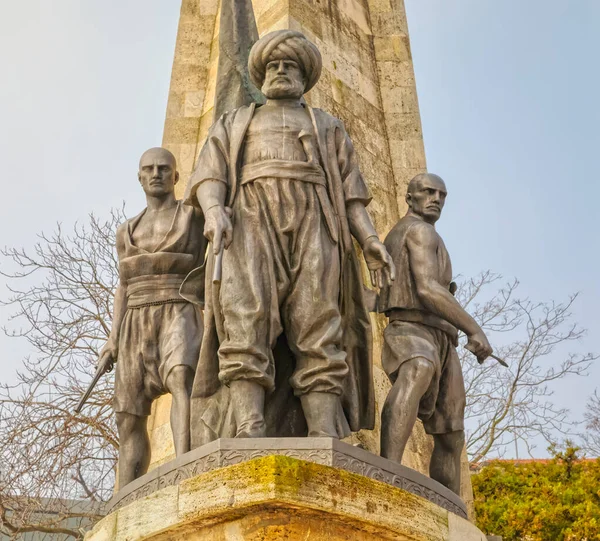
149 0 472 510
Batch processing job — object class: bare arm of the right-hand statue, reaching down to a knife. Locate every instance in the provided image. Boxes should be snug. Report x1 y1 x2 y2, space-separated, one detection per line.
406 224 492 362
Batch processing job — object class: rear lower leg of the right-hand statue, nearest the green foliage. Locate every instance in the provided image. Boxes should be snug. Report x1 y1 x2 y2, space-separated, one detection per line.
429 430 465 496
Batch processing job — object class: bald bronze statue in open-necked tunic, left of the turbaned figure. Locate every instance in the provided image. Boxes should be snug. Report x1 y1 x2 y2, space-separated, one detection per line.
99 148 206 488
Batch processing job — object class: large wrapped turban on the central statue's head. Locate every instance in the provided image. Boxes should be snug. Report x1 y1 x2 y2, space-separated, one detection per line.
248 30 323 92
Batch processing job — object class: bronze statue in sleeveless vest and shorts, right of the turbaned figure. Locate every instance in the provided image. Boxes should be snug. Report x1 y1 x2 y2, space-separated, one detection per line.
379 174 492 494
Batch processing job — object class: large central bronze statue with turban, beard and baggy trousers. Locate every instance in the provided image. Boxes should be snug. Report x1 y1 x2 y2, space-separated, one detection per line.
186 30 394 443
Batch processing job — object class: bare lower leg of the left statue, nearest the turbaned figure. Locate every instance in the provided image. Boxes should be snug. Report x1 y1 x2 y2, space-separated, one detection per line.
166 365 194 456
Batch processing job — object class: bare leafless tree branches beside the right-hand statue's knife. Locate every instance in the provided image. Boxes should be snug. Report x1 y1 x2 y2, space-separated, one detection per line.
457 271 597 462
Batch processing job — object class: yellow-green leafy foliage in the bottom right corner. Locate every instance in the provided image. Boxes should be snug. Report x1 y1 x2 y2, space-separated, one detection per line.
472 444 600 541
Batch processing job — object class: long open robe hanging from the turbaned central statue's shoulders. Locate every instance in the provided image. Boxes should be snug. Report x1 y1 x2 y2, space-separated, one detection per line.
185 104 375 447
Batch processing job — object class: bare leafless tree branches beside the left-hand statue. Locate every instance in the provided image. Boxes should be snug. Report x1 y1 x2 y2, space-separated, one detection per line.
0 206 124 539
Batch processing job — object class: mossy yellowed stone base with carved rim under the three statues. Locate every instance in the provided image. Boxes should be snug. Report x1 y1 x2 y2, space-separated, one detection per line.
85 438 486 541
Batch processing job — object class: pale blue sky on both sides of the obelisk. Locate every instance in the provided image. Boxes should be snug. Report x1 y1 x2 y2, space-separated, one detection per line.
0 0 600 456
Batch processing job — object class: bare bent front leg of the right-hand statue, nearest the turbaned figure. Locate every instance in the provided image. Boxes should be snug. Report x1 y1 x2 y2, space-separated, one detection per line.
381 357 435 464
